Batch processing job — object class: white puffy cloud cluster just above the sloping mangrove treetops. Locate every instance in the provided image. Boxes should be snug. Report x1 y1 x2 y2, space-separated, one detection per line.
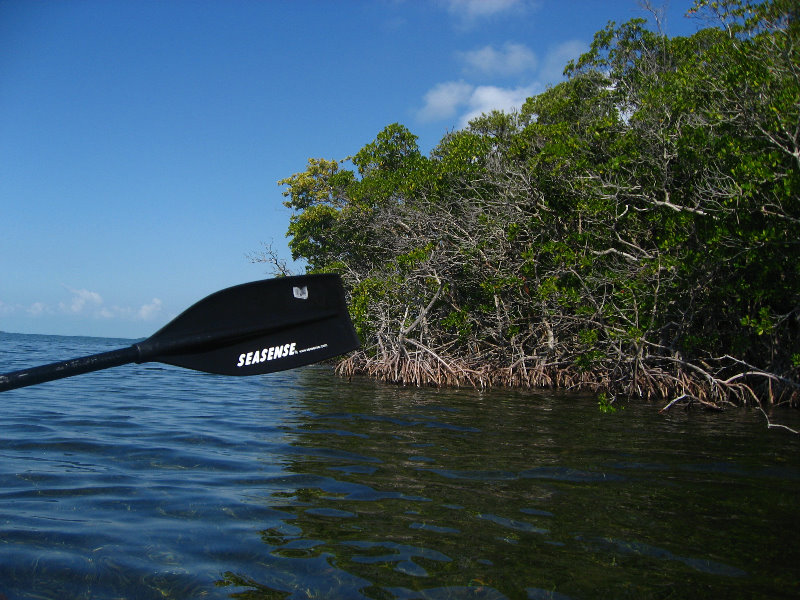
417 40 588 128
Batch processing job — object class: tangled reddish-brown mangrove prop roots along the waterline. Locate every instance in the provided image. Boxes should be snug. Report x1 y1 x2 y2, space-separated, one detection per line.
336 350 800 414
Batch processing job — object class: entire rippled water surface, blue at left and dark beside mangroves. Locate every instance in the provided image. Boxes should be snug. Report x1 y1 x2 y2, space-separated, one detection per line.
0 334 800 600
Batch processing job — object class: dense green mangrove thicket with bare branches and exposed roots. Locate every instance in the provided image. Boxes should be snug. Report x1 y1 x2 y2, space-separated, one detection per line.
254 0 800 414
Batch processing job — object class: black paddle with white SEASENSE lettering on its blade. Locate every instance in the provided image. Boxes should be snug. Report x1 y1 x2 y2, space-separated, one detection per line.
0 275 359 392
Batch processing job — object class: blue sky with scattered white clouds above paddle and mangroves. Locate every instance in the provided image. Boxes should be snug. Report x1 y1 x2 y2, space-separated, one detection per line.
0 0 701 337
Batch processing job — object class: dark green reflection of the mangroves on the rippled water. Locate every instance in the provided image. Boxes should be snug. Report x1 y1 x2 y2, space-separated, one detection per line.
223 370 800 598
